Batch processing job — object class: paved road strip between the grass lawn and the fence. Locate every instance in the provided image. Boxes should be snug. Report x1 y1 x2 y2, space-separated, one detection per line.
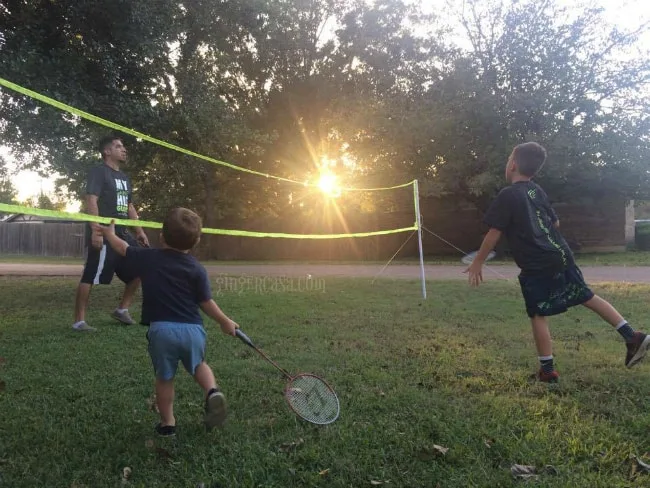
0 263 650 283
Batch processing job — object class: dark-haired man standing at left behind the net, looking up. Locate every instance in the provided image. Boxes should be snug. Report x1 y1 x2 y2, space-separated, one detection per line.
72 136 149 332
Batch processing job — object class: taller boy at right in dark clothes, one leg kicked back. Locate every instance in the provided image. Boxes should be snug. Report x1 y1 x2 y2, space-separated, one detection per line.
465 142 650 383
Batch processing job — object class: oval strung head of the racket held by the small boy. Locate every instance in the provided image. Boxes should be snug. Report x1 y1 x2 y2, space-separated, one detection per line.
285 374 339 424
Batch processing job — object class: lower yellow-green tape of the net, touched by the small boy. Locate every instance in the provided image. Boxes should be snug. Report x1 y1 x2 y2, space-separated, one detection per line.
0 203 417 239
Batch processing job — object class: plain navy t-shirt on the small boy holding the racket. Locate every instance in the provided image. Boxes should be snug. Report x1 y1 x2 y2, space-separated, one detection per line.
125 246 212 325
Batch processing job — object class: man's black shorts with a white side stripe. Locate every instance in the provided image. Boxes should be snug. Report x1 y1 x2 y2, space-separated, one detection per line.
81 233 139 285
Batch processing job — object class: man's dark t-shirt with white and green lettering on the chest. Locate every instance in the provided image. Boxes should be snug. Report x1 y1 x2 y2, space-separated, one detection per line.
86 164 132 240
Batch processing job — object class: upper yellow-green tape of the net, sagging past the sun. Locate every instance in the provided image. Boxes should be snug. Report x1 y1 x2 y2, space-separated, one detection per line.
0 78 414 191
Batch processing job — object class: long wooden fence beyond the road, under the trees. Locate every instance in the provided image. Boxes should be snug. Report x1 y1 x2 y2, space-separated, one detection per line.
0 199 634 261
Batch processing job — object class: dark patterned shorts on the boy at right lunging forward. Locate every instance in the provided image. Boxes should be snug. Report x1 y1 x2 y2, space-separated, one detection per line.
519 265 594 318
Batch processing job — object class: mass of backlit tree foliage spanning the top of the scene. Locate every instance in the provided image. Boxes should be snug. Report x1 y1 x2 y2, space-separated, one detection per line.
0 0 650 225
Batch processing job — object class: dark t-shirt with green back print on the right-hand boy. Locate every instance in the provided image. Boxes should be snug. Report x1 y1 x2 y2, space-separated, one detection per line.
483 181 575 273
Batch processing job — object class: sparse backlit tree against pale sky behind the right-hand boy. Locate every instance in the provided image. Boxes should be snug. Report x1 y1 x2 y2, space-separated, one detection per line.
346 0 650 208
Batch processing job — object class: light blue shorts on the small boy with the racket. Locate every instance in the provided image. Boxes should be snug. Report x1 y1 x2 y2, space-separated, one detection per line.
147 322 206 381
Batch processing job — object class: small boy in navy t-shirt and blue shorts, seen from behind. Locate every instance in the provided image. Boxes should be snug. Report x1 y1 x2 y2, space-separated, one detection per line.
102 208 239 436
